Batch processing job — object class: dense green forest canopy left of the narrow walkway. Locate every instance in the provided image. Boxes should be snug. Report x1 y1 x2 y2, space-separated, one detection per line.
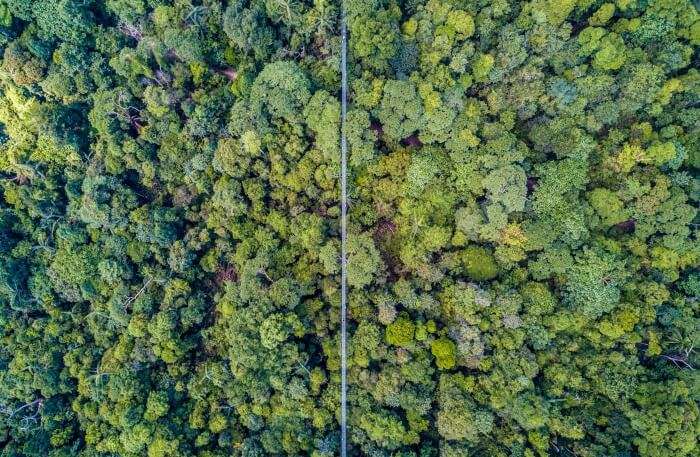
0 0 342 457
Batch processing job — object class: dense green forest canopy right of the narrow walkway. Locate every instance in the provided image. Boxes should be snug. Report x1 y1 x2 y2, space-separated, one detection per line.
344 0 700 456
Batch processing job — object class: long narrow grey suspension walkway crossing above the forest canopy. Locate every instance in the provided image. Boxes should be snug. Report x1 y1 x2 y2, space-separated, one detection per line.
340 0 348 457
